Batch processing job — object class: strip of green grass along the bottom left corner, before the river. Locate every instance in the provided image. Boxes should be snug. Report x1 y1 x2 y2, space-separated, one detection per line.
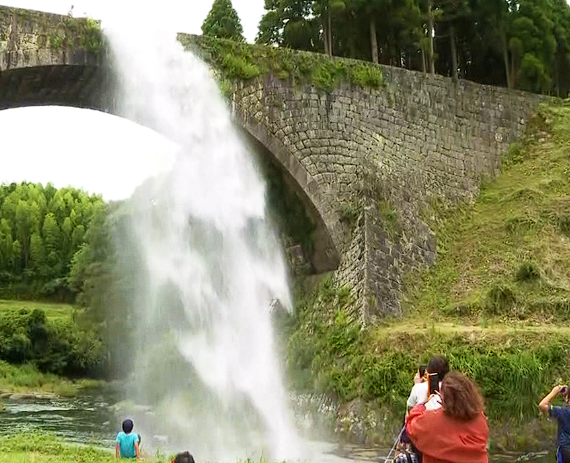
0 433 170 463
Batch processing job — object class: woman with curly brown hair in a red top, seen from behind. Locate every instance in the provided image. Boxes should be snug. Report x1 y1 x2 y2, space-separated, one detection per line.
406 372 489 463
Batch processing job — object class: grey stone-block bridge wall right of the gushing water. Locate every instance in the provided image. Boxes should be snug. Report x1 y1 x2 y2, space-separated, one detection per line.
233 67 541 322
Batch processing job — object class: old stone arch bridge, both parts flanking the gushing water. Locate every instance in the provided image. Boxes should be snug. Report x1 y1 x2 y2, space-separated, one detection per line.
0 7 541 322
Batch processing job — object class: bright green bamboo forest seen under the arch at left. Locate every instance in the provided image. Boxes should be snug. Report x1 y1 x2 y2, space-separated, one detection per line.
0 183 105 301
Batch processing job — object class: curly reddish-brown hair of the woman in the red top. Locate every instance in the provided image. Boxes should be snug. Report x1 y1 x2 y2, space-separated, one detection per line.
441 371 483 421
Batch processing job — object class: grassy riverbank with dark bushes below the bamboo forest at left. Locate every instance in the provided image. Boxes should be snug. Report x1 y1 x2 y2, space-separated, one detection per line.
0 300 104 398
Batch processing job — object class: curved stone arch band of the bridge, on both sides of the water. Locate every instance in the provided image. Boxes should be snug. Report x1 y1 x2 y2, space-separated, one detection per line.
0 60 340 273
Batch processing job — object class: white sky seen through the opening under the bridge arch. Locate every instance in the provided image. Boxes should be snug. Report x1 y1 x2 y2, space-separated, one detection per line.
0 106 176 200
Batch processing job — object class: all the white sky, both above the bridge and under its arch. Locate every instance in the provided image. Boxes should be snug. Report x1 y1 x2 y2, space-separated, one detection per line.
0 0 264 200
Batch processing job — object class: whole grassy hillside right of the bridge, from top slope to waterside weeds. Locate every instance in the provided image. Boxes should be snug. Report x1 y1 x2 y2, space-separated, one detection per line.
284 102 570 448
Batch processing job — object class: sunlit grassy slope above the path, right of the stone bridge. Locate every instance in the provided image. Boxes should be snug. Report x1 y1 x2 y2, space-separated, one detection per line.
405 102 570 323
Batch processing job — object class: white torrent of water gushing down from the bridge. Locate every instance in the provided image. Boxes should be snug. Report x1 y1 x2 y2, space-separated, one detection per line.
103 15 300 461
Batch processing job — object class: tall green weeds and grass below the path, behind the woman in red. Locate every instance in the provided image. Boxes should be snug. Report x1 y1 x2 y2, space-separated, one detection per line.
287 279 570 423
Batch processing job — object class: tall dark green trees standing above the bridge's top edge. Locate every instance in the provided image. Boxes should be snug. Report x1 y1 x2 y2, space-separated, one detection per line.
202 0 570 97
